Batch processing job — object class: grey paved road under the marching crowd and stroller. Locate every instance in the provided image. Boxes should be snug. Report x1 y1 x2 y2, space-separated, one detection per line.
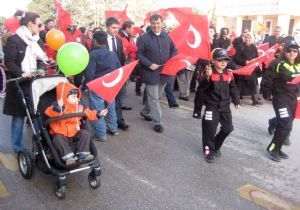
0 84 300 210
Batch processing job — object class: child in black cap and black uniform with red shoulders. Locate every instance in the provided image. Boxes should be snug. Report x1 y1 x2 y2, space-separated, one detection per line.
199 48 241 163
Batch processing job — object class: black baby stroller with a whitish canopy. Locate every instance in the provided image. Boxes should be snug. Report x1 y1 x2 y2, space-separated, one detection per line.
12 76 101 199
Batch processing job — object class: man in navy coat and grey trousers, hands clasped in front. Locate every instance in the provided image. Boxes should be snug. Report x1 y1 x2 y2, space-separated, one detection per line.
137 14 178 133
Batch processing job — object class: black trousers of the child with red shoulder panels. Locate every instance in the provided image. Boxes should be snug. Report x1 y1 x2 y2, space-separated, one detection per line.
202 108 233 152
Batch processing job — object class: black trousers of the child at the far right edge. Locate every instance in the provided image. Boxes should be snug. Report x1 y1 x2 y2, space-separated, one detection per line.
268 96 297 151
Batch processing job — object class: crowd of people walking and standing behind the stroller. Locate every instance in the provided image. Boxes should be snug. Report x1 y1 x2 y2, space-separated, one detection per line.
0 9 300 162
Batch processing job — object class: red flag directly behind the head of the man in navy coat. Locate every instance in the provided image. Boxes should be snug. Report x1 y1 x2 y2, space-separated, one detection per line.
144 7 192 26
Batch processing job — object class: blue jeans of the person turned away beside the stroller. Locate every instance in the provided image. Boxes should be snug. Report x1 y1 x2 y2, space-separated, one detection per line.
89 91 118 139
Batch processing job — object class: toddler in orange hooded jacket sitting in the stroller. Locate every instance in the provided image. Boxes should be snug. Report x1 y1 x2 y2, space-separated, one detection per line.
45 82 107 165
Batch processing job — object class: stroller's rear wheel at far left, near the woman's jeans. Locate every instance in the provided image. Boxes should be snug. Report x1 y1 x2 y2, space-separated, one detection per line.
18 149 34 179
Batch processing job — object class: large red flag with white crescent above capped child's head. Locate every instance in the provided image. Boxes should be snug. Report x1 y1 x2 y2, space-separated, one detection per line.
169 14 210 60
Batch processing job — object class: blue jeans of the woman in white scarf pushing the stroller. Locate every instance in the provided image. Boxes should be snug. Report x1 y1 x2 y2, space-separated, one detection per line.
11 116 25 152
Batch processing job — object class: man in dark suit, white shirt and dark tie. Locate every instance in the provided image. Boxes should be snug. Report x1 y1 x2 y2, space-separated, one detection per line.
105 17 131 130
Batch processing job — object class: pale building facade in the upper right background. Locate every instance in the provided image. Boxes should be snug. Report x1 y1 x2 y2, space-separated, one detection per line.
215 0 300 35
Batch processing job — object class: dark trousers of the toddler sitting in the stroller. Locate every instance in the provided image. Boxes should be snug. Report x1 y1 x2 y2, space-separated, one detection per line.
53 129 91 157
